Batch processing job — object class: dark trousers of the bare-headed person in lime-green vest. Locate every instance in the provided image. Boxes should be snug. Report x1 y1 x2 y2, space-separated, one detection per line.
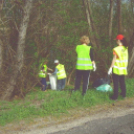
74 70 90 95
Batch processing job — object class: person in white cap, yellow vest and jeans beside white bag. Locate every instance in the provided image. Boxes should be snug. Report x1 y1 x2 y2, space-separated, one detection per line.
53 60 66 90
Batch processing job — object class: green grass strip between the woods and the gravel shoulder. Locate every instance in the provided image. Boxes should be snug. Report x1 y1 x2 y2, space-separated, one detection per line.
0 79 134 126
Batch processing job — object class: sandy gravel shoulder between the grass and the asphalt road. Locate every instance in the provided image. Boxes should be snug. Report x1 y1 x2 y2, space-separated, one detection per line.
0 98 134 134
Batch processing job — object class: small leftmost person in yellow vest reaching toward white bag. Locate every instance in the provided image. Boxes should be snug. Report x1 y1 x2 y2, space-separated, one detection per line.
38 61 53 91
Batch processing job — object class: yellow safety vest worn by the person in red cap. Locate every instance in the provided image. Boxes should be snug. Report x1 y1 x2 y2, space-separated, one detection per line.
113 46 128 75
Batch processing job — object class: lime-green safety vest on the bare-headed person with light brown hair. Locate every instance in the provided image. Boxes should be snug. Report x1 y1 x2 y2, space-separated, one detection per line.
76 45 93 70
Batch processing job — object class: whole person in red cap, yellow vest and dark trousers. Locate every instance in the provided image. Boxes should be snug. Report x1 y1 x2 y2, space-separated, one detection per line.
108 34 128 100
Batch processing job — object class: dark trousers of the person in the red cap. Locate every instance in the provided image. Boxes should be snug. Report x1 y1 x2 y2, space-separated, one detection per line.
112 73 126 98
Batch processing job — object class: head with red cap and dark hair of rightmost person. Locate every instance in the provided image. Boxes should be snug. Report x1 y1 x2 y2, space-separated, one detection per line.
116 34 128 47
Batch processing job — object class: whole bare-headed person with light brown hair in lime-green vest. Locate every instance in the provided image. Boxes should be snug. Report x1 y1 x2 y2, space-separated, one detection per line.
74 36 96 95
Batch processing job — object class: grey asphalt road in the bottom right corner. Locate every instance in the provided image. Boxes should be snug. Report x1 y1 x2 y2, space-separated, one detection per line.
49 114 134 134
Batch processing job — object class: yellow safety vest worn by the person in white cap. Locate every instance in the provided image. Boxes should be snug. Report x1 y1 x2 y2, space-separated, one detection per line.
56 64 66 80
